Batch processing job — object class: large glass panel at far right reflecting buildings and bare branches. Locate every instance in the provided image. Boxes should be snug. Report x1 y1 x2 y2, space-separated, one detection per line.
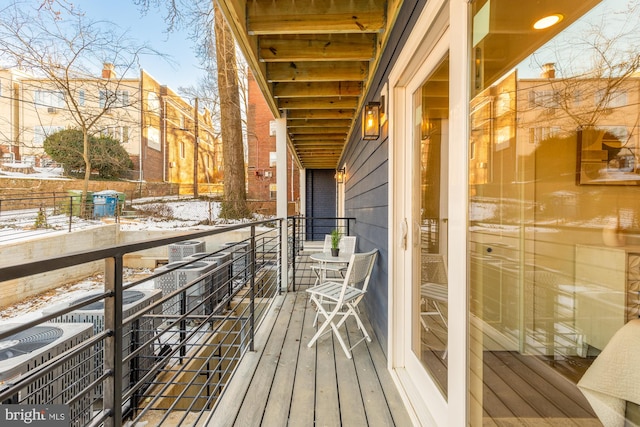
467 0 640 426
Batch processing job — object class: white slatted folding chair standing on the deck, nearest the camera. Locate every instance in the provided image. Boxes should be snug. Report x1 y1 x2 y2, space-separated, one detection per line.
307 249 378 359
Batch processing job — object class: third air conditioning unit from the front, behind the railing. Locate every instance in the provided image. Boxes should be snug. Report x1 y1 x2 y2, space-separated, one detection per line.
154 261 216 315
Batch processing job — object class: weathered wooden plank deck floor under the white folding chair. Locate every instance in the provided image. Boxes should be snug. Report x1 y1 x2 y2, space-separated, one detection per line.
208 290 411 427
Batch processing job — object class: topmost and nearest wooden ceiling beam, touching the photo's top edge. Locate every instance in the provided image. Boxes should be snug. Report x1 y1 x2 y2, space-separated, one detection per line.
247 0 387 35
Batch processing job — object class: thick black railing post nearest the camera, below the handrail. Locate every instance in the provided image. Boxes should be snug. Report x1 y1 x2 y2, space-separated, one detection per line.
103 256 123 427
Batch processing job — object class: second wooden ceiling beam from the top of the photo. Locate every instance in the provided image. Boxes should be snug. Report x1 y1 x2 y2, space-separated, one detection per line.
258 34 376 62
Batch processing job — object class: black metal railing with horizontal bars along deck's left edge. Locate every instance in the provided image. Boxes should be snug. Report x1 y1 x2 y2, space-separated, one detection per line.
0 220 283 426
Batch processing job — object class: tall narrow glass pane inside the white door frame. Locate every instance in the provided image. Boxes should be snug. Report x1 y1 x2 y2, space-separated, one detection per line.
411 55 449 395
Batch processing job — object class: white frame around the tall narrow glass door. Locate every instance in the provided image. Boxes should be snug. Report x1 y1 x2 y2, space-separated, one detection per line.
388 0 469 426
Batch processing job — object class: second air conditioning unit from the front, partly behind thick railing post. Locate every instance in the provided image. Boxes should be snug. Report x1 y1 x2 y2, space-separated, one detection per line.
42 289 162 395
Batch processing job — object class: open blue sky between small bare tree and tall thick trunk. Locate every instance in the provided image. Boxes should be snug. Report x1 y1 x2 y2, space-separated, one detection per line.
74 0 204 90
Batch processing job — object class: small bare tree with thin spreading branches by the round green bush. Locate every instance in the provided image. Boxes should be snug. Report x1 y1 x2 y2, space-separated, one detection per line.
0 0 157 214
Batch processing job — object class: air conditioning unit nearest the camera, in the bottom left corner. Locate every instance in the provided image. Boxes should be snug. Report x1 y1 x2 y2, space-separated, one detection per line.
0 323 94 426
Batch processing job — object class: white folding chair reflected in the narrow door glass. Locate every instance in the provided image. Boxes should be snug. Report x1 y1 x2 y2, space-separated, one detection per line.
420 254 448 359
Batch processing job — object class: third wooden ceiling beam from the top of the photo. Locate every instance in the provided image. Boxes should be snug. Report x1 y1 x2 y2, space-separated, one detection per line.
267 61 369 82
